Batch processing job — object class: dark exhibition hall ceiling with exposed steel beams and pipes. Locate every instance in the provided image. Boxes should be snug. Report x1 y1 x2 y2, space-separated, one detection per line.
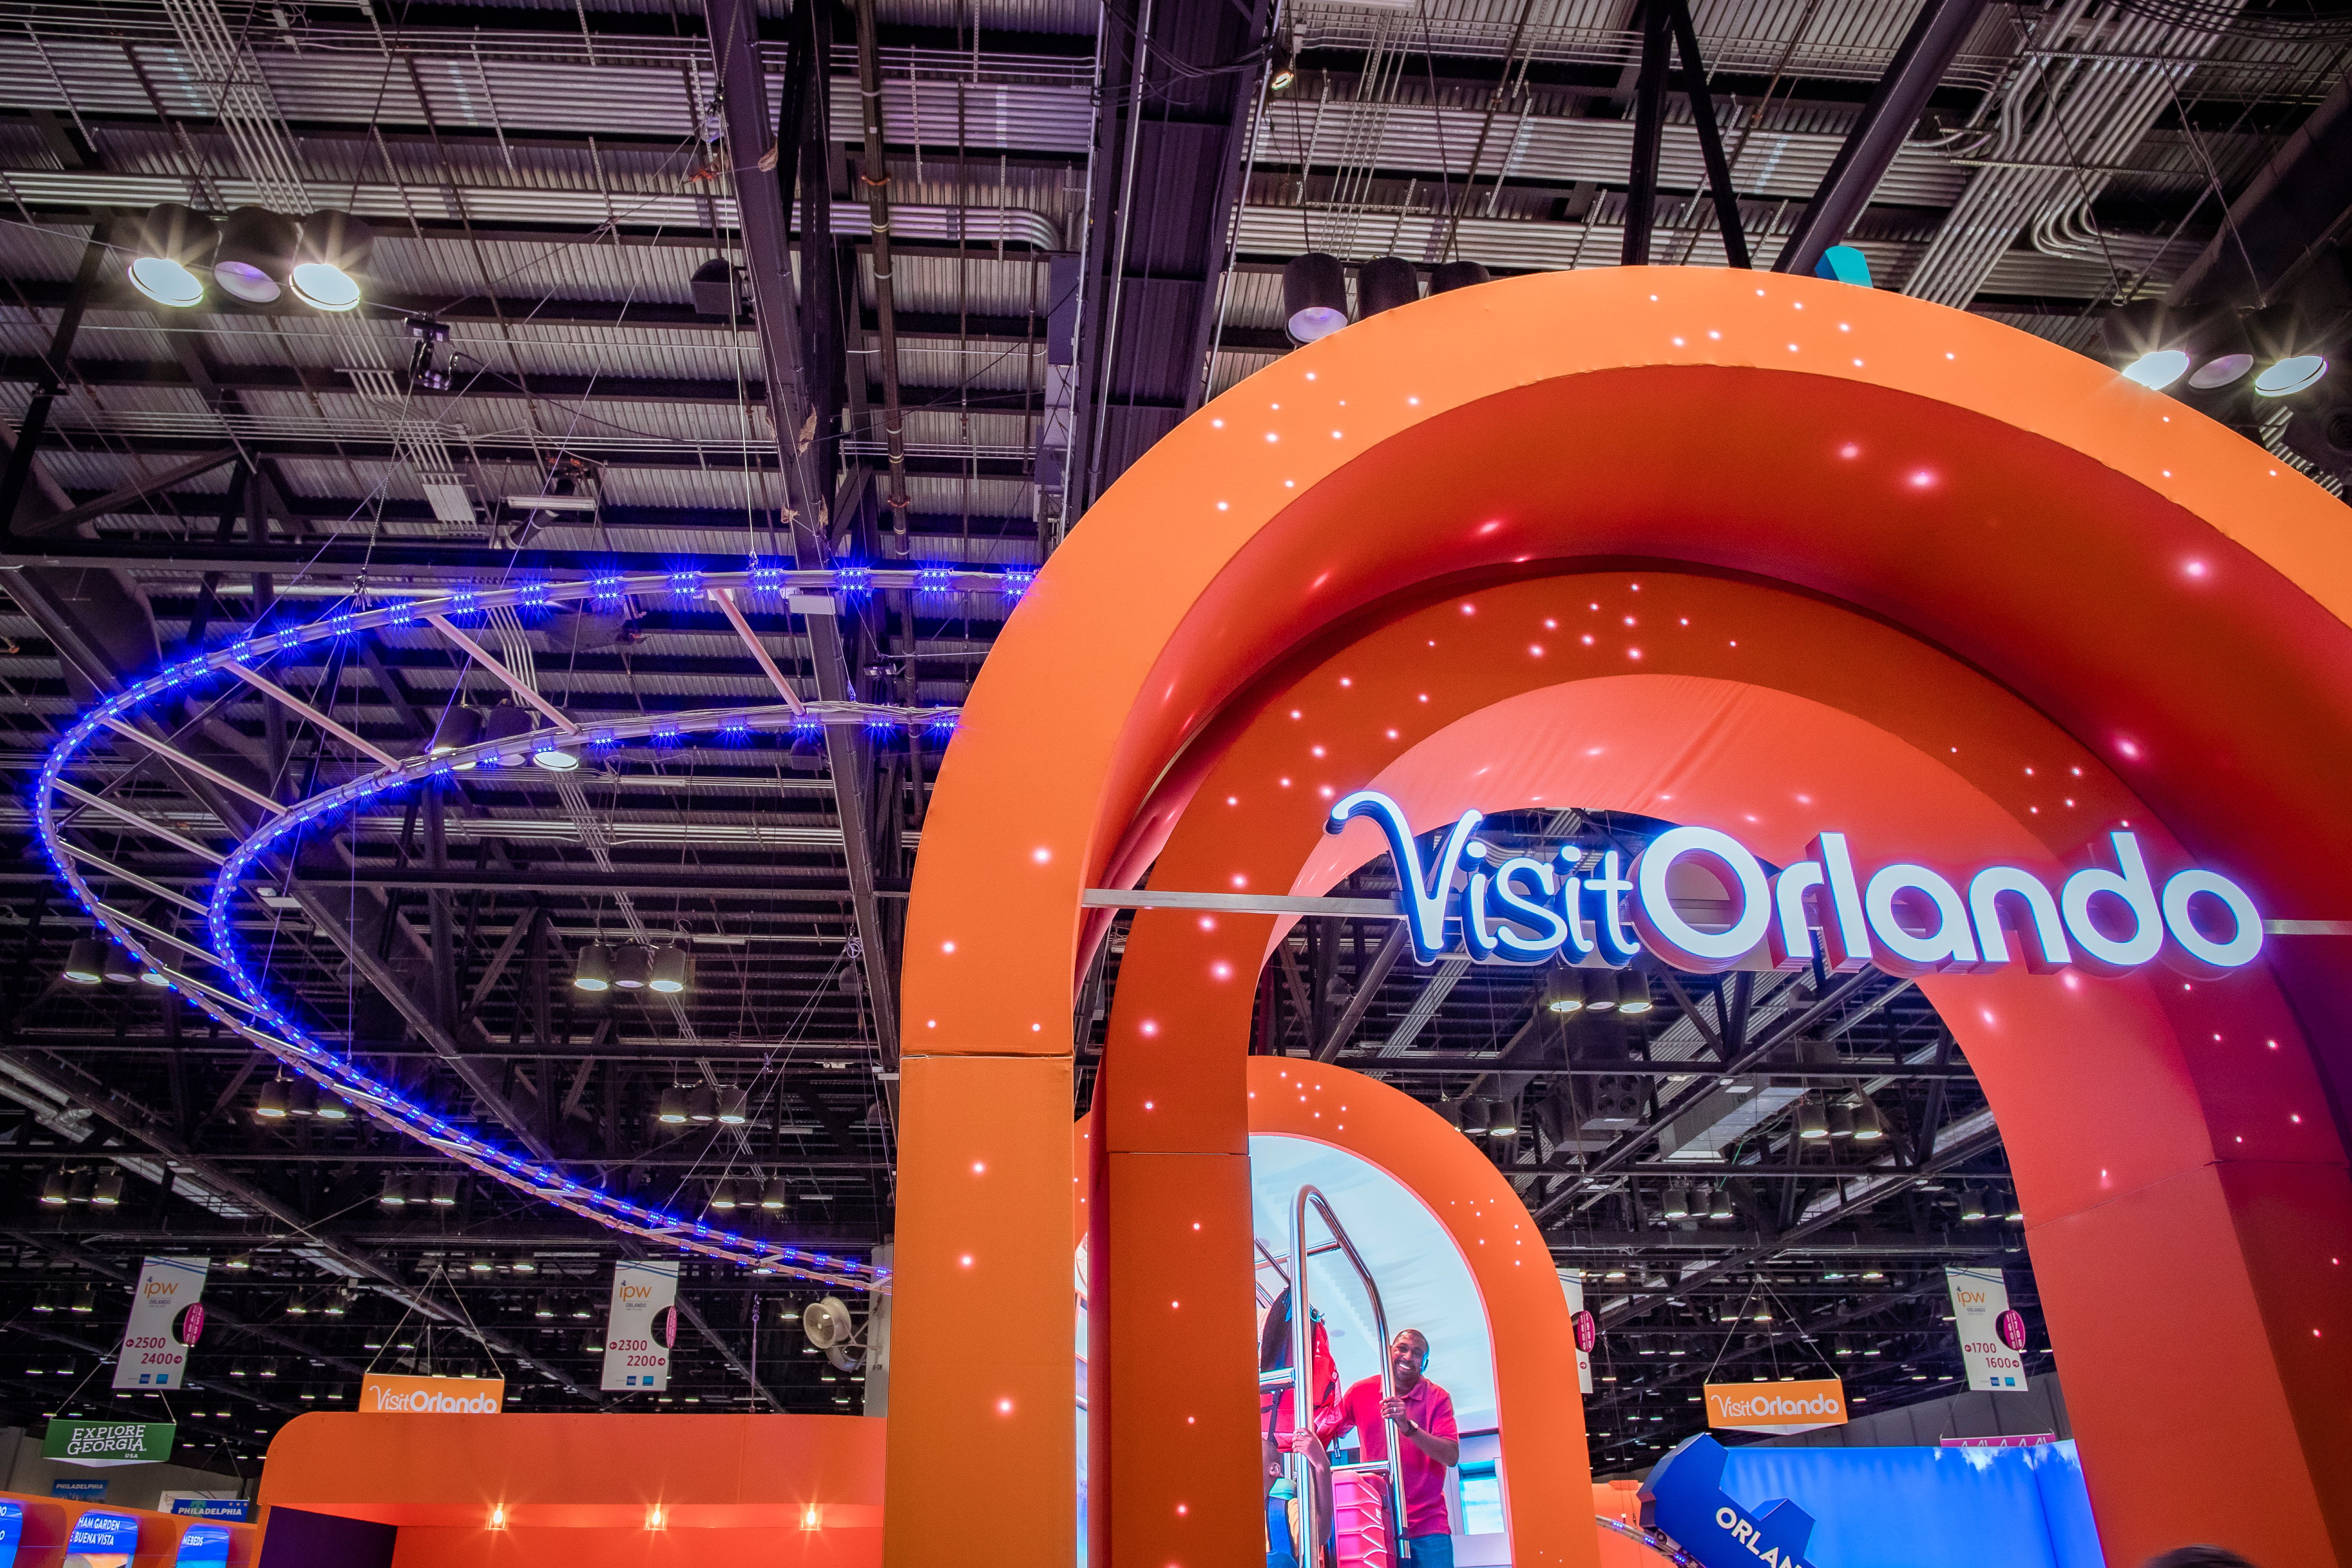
0 0 2352 1472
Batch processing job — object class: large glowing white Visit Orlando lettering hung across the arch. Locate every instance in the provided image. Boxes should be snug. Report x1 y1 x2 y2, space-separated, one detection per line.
1324 790 2263 975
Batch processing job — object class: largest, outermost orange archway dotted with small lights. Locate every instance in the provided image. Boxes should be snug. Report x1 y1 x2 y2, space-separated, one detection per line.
887 270 2352 1563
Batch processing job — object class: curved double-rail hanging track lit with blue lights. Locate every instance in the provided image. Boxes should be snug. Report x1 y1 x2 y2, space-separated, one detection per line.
33 562 1002 1291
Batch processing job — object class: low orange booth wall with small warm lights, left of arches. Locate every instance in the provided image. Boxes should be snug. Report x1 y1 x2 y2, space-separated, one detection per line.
261 1413 882 1568
